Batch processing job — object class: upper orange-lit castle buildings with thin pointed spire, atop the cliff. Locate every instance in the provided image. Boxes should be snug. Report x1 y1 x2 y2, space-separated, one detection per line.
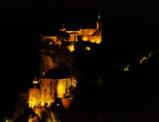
41 13 102 52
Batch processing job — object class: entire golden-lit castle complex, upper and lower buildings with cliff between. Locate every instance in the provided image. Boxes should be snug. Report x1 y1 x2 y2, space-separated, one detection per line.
28 15 102 116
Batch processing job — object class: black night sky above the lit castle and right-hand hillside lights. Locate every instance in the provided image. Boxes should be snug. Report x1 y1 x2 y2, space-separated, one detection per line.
0 0 159 120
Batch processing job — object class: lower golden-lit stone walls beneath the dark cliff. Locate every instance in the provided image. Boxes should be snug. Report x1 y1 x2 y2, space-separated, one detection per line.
28 78 74 108
